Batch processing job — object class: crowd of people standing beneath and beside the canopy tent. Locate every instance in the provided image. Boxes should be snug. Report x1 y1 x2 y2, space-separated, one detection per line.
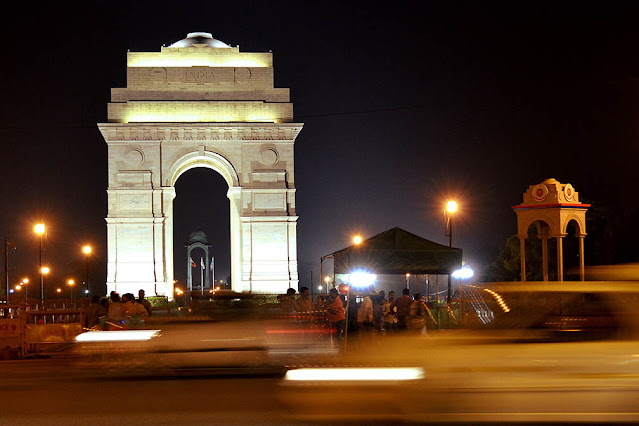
280 287 437 341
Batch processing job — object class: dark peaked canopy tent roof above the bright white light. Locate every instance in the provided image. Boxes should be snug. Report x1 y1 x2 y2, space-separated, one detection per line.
332 228 462 274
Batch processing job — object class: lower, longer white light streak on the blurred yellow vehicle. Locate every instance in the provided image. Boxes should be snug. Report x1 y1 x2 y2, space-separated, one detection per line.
284 368 424 382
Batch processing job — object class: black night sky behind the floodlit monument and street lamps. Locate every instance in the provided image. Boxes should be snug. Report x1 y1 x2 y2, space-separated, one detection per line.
0 1 639 292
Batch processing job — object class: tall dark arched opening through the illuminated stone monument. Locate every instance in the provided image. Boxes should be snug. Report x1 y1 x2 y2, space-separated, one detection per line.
173 167 231 289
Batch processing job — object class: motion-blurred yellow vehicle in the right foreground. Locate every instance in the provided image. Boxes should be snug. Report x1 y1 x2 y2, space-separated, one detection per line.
280 282 639 424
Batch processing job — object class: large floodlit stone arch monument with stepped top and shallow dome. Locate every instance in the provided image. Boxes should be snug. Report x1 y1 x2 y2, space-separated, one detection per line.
98 33 302 298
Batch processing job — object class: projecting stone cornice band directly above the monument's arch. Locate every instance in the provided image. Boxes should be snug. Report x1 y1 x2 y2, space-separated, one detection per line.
98 123 304 142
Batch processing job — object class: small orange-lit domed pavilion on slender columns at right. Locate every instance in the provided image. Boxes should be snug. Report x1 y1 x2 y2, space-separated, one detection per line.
512 178 590 281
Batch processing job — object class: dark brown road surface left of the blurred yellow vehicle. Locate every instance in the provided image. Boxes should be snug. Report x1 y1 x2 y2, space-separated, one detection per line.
0 360 297 425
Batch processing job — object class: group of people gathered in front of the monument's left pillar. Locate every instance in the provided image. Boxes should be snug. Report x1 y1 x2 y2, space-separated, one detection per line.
83 290 152 330
